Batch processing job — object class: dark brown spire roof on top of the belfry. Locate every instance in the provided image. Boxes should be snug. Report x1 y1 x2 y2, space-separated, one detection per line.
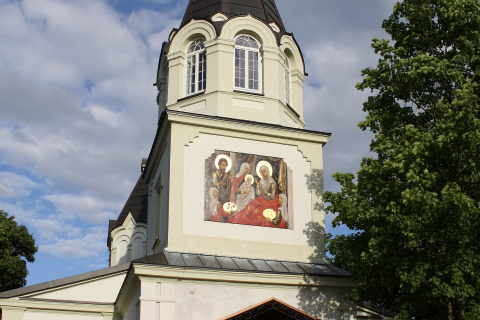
181 0 286 33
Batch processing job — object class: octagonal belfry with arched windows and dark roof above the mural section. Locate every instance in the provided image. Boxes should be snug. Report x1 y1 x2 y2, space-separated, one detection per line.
157 0 305 128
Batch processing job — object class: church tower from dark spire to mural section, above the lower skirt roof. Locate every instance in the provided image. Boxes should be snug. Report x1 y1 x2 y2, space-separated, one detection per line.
143 0 330 263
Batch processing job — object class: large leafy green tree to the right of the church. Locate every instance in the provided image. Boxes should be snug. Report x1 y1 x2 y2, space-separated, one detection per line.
324 0 480 320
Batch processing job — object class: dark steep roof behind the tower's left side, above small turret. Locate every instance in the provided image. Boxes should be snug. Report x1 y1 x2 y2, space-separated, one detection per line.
107 176 148 244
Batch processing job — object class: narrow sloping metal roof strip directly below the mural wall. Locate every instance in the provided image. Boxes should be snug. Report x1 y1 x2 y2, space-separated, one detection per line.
132 251 350 278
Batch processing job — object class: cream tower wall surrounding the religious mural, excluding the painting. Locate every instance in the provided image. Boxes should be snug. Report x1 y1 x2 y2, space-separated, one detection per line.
147 114 327 262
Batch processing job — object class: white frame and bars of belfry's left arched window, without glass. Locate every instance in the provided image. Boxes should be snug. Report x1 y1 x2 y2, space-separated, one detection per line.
185 38 207 96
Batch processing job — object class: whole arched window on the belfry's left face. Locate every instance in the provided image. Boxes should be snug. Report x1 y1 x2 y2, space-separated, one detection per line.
187 39 207 95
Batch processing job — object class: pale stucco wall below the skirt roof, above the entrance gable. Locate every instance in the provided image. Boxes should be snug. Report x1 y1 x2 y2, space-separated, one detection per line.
131 274 356 320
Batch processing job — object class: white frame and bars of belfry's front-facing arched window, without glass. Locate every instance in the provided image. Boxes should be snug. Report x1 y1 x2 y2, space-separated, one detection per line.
233 34 263 93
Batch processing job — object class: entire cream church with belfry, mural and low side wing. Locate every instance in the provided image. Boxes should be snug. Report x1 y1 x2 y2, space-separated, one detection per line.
0 0 394 320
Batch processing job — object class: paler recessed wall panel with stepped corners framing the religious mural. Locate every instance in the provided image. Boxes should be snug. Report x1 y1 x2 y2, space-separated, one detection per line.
178 134 312 261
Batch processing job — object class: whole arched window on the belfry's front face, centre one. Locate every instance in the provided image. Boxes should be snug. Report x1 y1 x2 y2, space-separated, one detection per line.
235 35 261 92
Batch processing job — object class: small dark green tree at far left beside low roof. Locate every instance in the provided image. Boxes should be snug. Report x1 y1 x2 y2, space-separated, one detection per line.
0 210 38 292
